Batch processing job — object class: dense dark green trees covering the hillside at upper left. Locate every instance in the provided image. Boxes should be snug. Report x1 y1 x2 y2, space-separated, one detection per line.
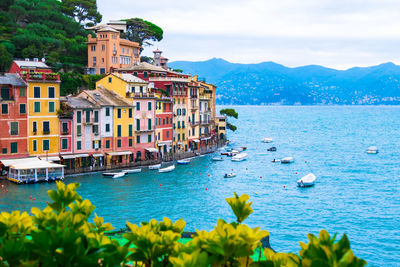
0 0 93 71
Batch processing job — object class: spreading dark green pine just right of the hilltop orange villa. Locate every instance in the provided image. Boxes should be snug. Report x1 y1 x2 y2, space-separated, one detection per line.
124 18 163 46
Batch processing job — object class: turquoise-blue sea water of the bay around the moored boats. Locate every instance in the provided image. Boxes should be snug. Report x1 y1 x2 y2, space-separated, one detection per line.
0 106 400 266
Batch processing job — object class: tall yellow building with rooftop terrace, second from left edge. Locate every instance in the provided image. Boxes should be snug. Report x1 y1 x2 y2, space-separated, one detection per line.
24 73 60 156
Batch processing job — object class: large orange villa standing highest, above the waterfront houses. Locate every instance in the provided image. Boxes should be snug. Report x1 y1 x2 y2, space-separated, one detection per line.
86 26 140 74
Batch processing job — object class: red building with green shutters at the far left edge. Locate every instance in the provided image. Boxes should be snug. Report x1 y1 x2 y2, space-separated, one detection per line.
0 73 29 159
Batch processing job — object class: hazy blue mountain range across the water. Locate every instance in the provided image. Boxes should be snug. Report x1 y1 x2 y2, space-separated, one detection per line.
169 58 400 105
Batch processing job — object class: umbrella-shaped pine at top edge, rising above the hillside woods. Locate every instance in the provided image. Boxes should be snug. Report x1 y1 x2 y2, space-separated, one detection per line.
62 0 102 26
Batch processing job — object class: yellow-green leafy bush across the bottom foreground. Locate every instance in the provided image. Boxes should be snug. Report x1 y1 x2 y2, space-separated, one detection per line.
0 182 366 267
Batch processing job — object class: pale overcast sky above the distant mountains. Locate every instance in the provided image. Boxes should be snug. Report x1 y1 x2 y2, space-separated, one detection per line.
97 0 400 69
